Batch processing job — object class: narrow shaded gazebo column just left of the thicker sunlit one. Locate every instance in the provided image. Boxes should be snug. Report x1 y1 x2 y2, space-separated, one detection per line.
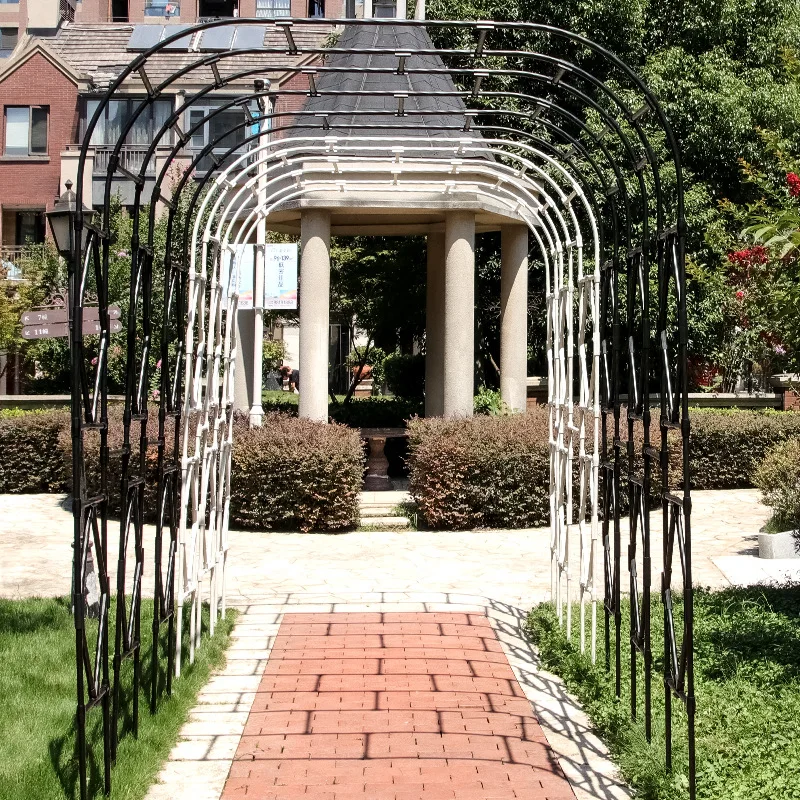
425 233 444 417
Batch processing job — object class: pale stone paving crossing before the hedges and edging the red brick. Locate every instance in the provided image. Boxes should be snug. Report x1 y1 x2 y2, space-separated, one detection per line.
0 490 800 800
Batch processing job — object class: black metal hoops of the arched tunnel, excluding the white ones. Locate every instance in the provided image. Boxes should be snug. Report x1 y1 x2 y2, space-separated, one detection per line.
69 19 695 798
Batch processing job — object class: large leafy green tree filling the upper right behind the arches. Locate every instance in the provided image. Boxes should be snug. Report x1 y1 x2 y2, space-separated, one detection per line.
427 0 800 384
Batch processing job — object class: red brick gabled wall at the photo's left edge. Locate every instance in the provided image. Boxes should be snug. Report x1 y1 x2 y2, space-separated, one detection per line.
0 53 78 244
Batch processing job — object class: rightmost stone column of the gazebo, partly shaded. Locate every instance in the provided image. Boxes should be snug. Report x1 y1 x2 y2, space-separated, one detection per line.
500 225 528 411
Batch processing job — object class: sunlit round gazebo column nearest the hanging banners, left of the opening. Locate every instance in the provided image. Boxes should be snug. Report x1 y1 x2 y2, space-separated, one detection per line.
300 209 331 422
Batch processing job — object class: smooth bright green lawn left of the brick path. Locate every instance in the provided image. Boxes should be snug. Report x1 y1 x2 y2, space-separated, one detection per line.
0 599 235 800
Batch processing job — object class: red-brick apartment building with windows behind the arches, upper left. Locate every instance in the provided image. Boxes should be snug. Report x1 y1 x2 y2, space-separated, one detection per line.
0 0 358 250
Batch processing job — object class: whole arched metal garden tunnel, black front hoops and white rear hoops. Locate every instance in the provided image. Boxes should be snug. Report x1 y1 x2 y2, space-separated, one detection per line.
62 19 695 798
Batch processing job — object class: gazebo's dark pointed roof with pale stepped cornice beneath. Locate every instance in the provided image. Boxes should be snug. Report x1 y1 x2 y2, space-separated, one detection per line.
262 24 532 235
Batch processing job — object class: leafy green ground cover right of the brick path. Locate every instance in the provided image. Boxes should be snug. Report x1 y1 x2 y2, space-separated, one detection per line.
528 586 800 800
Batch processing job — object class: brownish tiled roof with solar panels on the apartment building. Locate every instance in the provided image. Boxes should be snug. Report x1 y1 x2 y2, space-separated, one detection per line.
47 23 333 87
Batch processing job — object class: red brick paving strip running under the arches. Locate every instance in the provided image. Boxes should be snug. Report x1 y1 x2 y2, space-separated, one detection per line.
222 613 575 800
